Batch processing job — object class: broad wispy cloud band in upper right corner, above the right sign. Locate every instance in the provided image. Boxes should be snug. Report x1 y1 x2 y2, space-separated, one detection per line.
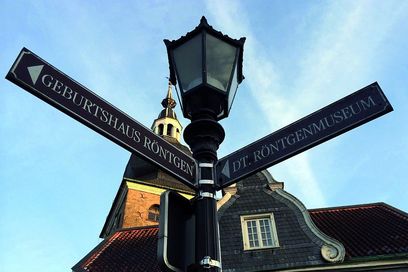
294 1 407 107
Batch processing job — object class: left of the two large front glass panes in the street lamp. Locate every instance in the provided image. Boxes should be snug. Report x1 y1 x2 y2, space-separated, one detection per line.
173 35 203 92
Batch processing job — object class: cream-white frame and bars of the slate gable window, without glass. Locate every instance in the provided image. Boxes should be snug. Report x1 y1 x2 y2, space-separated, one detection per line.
241 213 279 250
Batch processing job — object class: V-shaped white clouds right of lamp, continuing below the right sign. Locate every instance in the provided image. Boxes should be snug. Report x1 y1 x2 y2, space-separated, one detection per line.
207 0 407 207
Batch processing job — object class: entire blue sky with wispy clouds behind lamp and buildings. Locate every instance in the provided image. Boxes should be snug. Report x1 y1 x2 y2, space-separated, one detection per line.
0 0 408 271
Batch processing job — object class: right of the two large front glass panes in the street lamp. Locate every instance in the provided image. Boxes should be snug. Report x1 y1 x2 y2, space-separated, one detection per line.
206 34 237 92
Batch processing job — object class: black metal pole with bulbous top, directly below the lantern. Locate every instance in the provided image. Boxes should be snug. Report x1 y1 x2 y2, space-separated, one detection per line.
184 109 225 272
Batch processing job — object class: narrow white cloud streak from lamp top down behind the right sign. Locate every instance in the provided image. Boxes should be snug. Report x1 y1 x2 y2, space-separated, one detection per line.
207 1 326 206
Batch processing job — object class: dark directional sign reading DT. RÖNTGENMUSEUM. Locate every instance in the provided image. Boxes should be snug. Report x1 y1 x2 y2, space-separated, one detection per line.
216 82 393 188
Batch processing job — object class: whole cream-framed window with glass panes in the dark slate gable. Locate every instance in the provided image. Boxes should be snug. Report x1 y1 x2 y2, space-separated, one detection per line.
241 213 279 250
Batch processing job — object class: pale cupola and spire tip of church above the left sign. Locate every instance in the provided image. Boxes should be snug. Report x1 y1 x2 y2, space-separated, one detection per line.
152 81 182 143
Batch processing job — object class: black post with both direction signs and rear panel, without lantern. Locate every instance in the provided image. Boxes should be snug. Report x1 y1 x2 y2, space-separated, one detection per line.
6 39 393 271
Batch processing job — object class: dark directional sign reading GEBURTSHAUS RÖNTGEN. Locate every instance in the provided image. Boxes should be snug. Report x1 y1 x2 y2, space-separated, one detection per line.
6 48 196 188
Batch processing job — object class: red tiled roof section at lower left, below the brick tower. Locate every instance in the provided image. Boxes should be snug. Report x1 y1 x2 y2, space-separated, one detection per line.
72 226 161 272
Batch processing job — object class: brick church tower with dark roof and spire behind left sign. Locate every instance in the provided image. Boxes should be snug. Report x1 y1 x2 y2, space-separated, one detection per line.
100 82 194 238
